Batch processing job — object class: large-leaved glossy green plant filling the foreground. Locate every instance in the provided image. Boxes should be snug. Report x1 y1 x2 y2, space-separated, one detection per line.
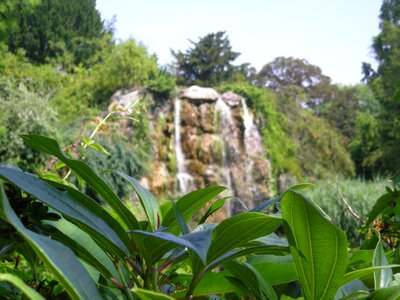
0 135 398 299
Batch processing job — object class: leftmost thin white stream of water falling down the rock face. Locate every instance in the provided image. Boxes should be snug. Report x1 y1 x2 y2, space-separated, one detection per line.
174 98 193 194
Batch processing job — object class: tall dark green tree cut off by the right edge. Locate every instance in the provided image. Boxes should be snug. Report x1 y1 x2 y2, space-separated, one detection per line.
363 0 400 173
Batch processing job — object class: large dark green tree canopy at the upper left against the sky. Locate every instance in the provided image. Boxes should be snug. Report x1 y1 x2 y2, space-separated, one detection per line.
7 0 105 64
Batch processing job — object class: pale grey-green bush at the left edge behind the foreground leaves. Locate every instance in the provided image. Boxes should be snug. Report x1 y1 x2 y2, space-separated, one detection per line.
0 77 57 167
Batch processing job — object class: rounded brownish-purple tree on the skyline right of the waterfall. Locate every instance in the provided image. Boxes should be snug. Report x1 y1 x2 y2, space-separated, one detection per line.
256 57 333 109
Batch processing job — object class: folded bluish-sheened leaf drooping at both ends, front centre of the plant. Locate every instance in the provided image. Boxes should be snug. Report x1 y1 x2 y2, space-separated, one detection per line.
132 229 212 264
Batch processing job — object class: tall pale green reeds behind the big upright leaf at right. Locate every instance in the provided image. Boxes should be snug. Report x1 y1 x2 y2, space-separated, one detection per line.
307 178 389 247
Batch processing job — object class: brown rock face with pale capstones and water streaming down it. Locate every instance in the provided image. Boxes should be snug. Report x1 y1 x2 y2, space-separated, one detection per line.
142 86 271 216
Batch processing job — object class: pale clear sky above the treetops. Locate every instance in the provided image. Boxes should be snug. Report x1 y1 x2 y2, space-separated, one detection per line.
97 0 382 84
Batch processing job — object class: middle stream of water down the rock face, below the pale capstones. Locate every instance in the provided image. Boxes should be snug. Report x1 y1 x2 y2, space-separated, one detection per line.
214 97 237 217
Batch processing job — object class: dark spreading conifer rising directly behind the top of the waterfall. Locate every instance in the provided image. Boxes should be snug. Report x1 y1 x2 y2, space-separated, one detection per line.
171 31 240 86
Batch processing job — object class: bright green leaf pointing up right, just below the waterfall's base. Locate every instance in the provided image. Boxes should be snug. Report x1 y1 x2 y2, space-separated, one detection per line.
161 186 226 233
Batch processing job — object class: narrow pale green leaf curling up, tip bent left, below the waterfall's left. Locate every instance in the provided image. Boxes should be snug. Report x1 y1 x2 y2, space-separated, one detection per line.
115 171 159 231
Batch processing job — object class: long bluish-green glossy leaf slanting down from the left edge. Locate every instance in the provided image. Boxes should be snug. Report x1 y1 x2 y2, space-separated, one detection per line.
0 166 129 258
